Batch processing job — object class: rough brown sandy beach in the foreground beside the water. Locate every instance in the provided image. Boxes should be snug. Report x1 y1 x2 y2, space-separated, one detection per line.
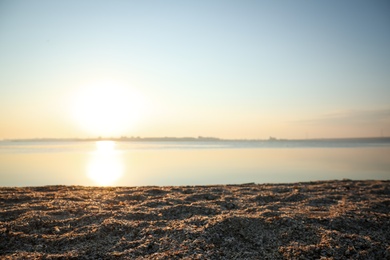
0 180 390 259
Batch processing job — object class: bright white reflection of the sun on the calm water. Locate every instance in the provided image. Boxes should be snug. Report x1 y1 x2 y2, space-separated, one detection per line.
87 141 123 186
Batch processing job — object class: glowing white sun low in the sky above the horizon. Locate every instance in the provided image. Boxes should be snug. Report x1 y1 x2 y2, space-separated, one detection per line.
72 81 143 136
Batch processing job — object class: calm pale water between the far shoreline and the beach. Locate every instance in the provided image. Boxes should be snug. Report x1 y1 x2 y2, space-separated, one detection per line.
0 139 390 186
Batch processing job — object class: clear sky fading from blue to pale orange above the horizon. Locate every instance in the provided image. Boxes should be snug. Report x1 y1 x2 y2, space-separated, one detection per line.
0 0 390 140
